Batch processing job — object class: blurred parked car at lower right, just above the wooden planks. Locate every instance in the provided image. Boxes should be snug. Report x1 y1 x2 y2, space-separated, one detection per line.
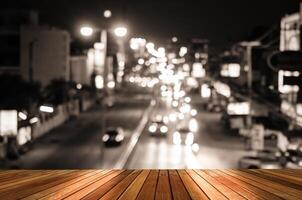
239 150 286 169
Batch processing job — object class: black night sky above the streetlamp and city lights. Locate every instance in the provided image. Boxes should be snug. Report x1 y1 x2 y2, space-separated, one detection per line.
4 0 299 45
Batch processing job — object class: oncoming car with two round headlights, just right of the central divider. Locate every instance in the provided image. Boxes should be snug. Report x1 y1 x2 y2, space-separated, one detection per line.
148 115 169 136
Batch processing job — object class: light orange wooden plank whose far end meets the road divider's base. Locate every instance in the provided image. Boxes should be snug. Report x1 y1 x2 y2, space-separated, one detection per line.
65 170 123 200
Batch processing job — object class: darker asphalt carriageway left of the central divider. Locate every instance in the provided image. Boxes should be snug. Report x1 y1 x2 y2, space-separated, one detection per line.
7 95 150 169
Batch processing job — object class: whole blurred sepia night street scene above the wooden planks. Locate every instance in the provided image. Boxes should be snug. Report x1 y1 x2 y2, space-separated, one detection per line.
0 0 302 172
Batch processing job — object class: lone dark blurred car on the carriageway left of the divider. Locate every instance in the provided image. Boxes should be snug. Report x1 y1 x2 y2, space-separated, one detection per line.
102 128 125 147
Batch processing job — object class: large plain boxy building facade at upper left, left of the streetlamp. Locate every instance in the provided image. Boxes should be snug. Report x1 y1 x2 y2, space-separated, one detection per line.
20 26 70 87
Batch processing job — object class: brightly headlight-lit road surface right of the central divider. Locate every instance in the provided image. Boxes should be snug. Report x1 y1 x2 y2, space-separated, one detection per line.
126 95 248 169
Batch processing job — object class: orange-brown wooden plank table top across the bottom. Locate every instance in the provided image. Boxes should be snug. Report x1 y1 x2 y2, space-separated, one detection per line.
0 170 302 200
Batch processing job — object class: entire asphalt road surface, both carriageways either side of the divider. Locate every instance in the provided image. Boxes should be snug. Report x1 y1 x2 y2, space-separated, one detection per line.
7 85 248 169
